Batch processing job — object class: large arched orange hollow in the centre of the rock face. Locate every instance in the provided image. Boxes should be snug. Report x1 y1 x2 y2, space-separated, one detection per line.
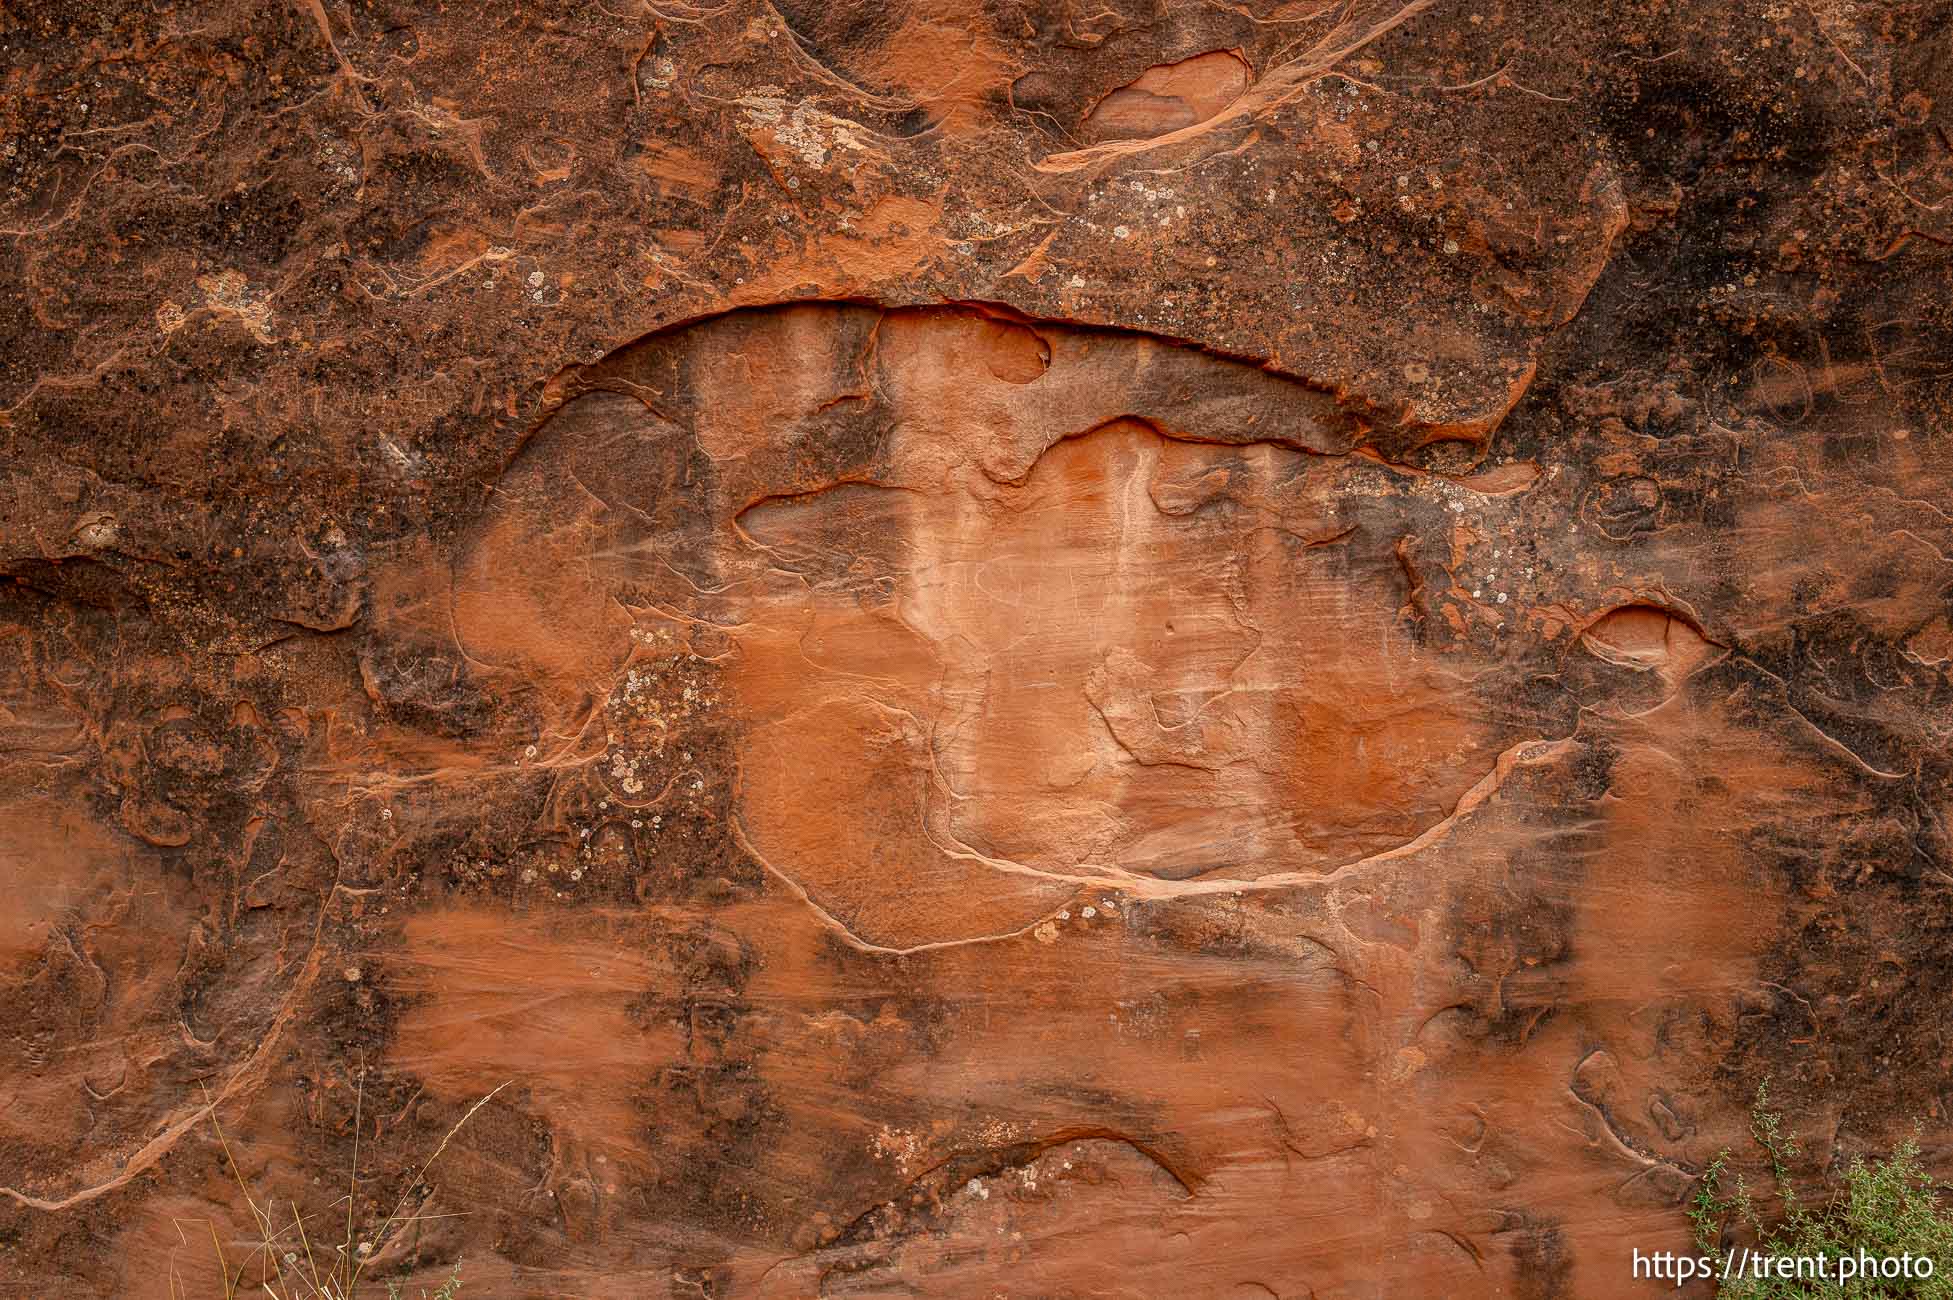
455 305 1510 945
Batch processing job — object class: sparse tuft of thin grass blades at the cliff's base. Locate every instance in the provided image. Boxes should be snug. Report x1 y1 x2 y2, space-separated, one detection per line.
170 1083 508 1300
